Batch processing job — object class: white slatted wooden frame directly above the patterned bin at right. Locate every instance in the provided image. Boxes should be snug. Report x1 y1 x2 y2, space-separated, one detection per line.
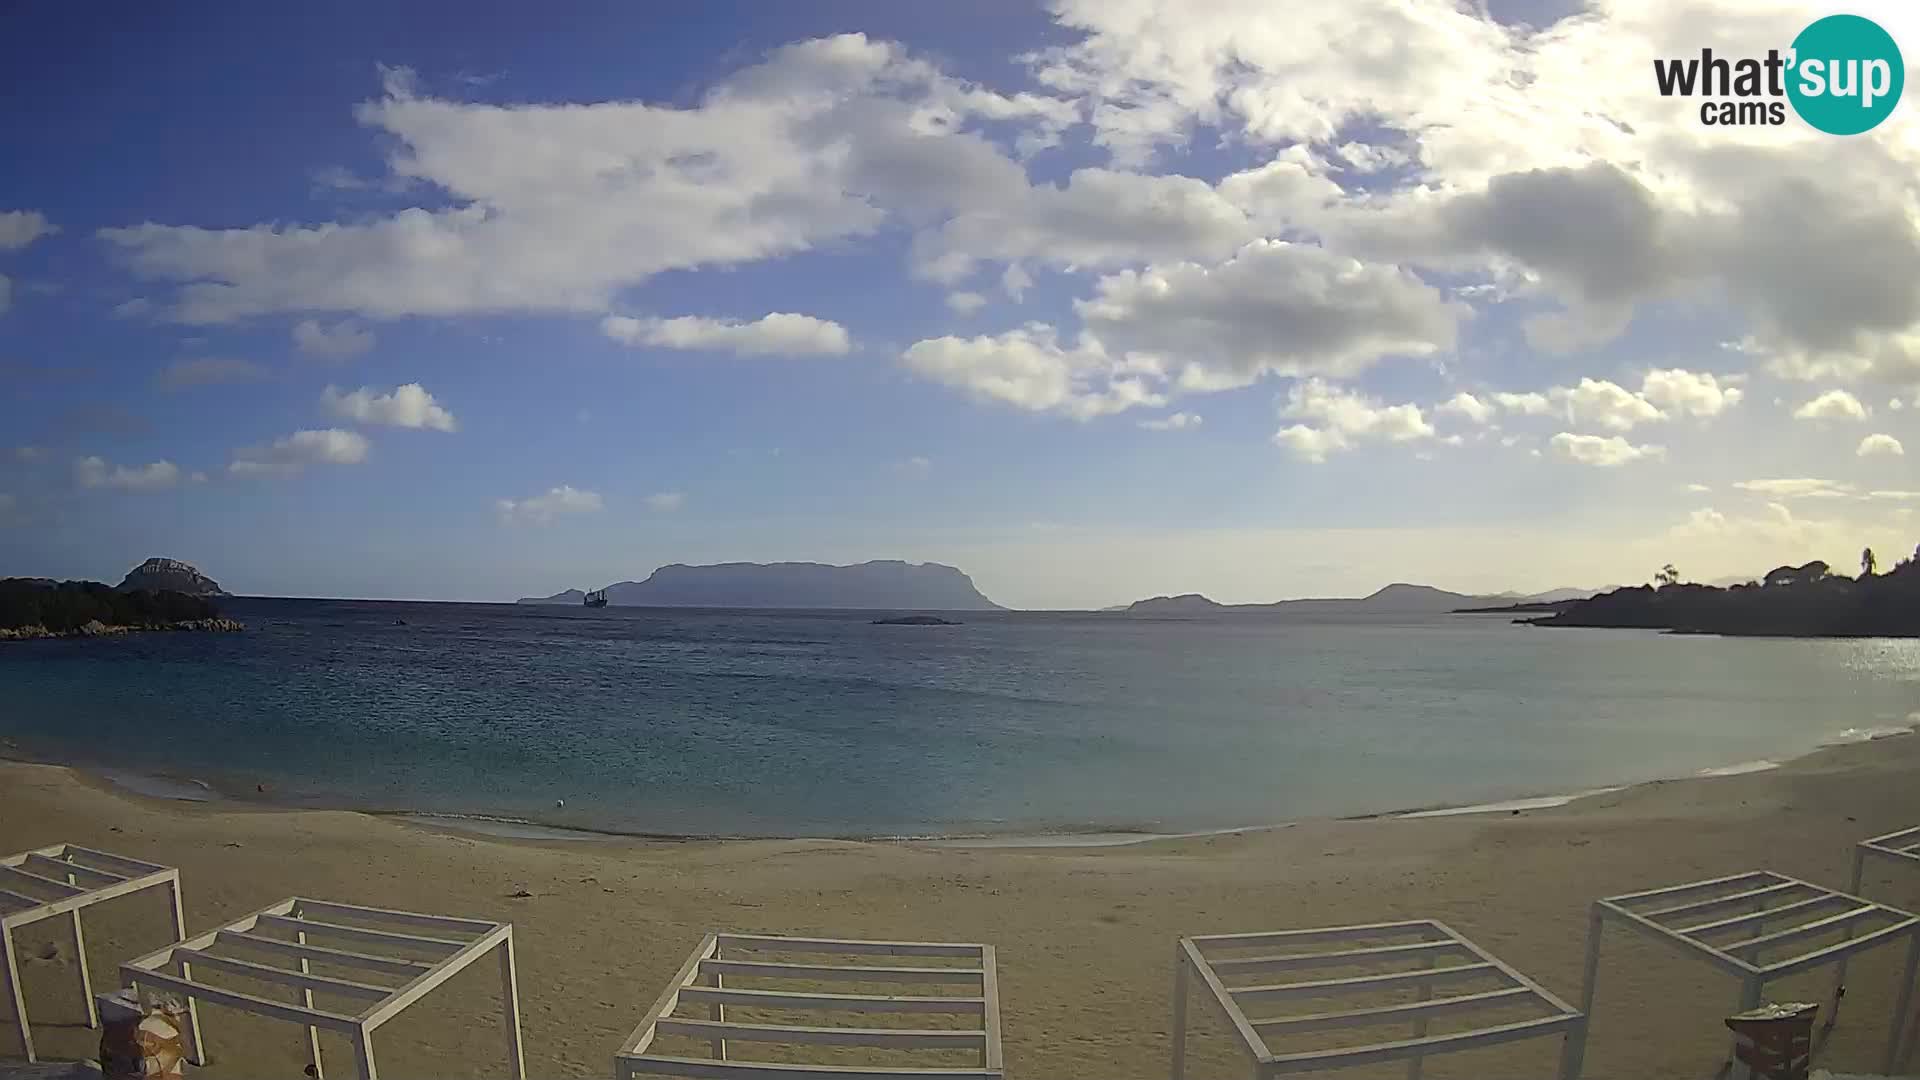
1582 871 1920 1080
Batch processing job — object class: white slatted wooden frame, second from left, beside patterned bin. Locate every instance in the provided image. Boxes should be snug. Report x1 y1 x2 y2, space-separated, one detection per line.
121 897 526 1080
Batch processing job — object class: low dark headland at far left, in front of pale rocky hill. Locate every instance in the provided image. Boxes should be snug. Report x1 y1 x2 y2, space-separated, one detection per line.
0 561 242 640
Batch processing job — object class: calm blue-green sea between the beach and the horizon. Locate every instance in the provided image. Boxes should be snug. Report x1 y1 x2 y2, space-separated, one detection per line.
0 598 1920 840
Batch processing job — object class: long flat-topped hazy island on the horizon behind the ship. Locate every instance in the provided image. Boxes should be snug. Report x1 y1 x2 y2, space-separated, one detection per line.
520 559 1004 611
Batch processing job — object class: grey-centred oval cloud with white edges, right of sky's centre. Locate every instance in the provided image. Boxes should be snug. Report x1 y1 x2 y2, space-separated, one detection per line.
1073 240 1465 390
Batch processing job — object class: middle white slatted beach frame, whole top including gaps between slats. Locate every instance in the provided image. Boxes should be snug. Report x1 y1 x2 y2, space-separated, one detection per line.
614 934 1004 1080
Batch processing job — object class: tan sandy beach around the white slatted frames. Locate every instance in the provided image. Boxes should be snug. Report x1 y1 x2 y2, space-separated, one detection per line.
0 736 1920 1080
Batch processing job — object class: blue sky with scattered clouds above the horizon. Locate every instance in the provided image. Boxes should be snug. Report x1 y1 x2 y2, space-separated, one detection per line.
0 0 1920 607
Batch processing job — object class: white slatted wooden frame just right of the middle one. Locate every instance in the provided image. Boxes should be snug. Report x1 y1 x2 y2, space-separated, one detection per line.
1173 919 1586 1080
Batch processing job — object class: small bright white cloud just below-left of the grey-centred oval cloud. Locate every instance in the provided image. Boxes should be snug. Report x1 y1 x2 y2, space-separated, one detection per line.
900 323 1165 421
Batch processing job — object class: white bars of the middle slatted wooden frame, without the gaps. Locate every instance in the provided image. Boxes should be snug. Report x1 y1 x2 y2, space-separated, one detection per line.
612 934 1004 1080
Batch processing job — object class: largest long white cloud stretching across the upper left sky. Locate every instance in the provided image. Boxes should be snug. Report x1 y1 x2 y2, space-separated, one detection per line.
102 35 1075 323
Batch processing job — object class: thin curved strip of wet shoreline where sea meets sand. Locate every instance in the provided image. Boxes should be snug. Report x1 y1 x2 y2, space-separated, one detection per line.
18 713 1920 849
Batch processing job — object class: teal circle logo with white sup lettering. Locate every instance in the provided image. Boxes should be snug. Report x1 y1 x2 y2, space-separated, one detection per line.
1788 15 1907 135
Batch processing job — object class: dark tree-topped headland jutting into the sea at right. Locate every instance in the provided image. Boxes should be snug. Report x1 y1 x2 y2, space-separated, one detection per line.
1523 550 1920 638
